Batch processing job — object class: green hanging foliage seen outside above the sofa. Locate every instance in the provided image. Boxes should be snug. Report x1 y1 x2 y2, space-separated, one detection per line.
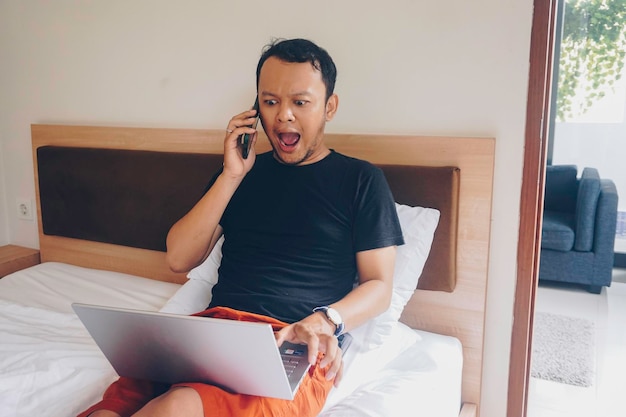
556 0 626 121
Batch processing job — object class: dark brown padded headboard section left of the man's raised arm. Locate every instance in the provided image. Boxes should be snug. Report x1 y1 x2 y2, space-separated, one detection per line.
37 146 223 251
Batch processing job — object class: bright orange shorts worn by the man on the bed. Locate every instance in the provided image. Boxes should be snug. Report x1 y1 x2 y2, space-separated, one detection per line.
78 307 333 417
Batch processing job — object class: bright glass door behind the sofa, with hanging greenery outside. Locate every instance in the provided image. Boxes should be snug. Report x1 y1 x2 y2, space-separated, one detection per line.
548 0 626 268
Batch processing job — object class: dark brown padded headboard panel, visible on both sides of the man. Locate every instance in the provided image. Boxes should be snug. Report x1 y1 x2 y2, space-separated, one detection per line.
37 146 459 291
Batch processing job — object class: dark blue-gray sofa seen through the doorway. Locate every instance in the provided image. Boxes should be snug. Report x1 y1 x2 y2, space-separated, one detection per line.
539 165 618 294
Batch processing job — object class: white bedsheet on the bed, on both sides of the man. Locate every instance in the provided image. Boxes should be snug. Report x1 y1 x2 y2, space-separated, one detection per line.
0 263 462 417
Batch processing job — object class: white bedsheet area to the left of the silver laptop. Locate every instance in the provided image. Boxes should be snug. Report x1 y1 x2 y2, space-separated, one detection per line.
0 262 180 417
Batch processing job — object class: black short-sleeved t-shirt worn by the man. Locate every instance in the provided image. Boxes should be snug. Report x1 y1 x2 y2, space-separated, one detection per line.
210 151 404 322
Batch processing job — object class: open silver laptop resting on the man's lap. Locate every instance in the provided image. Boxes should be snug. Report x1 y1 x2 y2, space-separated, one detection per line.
72 303 351 399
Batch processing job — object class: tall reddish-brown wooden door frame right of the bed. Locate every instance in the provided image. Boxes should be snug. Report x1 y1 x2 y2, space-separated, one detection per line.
507 0 558 417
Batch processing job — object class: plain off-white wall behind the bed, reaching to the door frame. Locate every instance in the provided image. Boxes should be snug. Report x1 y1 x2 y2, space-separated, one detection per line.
0 0 532 417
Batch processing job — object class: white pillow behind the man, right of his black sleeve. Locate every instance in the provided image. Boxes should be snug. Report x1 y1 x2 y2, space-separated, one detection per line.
350 203 440 349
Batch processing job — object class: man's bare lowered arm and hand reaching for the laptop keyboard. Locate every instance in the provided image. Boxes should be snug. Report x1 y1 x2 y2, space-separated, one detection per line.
276 246 396 385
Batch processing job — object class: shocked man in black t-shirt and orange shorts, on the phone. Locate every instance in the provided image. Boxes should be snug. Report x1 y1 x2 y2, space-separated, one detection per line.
78 39 404 417
